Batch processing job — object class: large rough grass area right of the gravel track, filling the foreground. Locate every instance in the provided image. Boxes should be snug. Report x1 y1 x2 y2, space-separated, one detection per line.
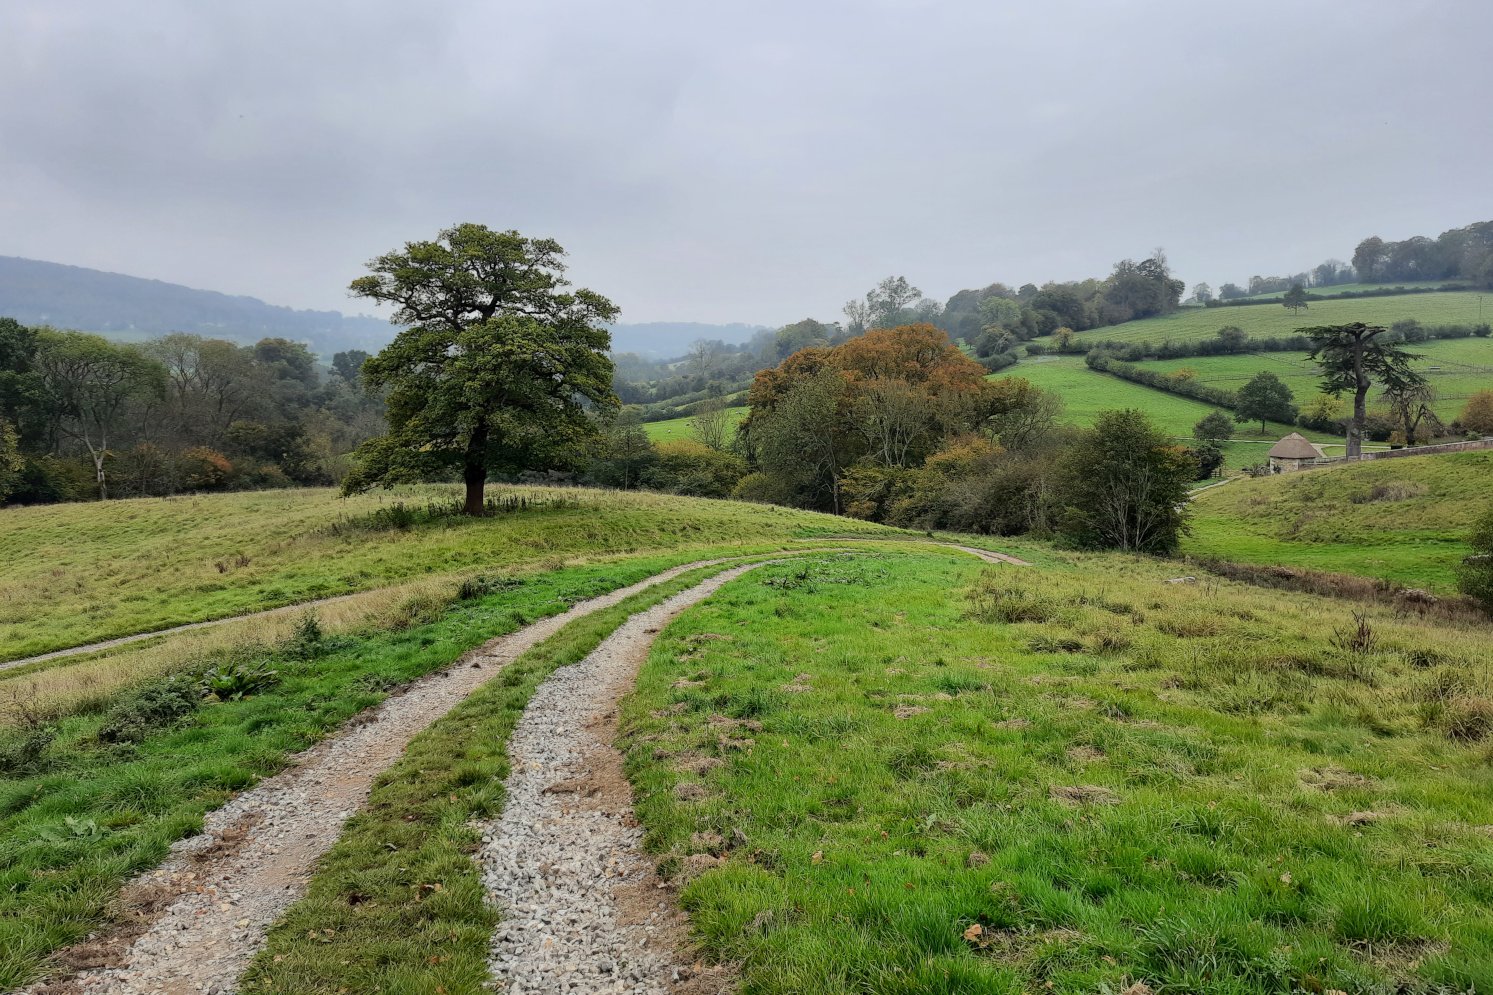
623 554 1493 995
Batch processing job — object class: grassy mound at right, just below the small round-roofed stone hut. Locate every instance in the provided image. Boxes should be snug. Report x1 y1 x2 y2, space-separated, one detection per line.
1182 453 1493 592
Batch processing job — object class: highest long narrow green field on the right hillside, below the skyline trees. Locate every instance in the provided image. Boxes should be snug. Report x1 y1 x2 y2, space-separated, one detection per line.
1068 290 1493 344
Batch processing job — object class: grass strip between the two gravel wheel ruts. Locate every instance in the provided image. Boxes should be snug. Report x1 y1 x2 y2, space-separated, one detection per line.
243 552 782 995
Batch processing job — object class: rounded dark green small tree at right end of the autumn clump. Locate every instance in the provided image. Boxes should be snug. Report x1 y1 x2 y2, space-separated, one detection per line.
1057 409 1197 553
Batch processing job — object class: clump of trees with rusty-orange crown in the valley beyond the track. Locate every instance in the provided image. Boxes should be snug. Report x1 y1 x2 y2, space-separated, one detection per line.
733 324 1200 553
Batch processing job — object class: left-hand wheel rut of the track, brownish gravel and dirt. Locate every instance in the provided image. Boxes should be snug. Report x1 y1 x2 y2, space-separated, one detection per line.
28 560 740 995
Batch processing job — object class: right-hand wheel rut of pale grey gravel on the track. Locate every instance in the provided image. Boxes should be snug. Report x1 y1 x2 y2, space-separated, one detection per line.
481 563 761 995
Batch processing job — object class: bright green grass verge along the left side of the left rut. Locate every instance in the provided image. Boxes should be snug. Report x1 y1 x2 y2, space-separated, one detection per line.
0 553 794 991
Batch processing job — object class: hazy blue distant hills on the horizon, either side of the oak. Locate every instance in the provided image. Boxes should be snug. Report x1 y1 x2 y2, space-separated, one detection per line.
0 255 758 359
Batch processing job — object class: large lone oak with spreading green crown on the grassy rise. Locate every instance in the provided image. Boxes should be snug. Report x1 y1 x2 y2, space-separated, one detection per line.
343 224 617 515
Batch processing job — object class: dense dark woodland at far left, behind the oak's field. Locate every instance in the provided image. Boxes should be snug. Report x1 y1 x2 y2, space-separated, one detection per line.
0 318 384 503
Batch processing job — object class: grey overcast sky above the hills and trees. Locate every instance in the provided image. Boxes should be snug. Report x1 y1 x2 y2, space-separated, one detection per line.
0 0 1493 324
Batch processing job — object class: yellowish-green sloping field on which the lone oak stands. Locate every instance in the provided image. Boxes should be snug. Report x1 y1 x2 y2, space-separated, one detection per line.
0 486 890 660
